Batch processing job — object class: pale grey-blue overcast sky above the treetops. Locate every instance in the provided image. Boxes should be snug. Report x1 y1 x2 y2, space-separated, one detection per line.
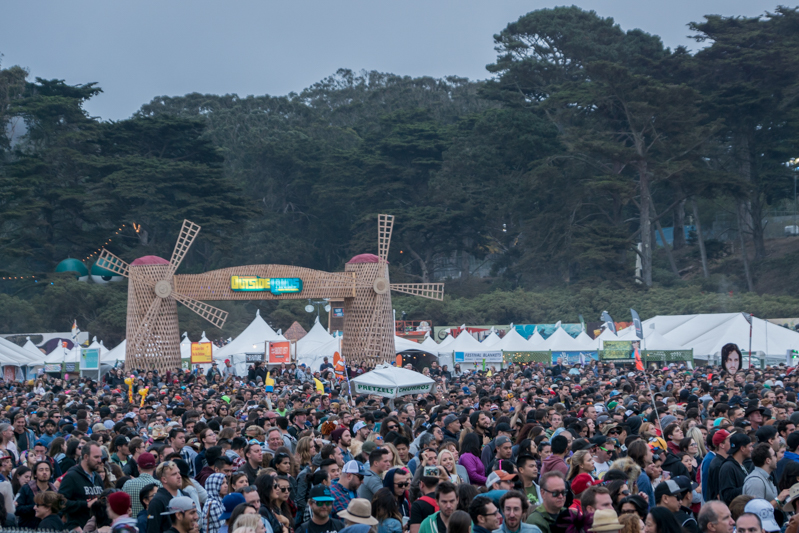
0 0 779 120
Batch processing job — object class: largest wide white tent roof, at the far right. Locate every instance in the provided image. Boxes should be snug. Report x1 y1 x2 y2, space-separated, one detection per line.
644 313 799 358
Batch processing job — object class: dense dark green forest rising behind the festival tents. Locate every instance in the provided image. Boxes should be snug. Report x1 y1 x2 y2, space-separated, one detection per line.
0 7 799 343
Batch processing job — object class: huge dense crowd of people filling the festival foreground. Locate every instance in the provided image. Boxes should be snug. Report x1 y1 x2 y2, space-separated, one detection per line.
0 345 799 533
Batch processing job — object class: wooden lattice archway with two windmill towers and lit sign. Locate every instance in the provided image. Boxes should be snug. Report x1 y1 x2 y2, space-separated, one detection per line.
97 215 444 371
